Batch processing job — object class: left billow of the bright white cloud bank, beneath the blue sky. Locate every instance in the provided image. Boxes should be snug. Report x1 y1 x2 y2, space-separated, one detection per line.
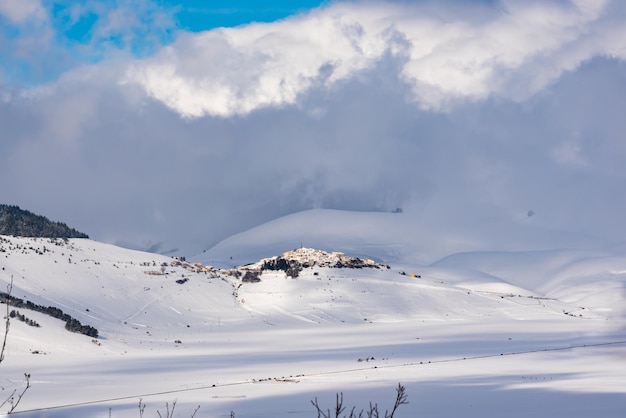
127 3 388 117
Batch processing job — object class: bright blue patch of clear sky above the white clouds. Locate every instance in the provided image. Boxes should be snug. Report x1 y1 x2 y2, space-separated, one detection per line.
0 0 327 86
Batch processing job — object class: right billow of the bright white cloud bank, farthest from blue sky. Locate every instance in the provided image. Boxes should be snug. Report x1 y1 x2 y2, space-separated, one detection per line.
402 1 603 109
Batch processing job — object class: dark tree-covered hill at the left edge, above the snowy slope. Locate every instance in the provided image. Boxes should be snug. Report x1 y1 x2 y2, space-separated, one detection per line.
0 204 89 238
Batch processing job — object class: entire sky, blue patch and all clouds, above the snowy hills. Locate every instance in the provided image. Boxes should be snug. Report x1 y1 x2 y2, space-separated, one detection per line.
0 0 626 255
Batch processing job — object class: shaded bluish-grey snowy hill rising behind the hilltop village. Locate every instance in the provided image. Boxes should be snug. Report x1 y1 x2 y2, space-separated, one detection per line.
193 209 613 266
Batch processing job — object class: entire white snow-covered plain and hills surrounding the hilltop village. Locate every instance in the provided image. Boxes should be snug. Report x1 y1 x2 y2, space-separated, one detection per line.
0 210 626 418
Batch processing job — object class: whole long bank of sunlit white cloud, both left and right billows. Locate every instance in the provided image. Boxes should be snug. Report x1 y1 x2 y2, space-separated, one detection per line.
125 0 626 118
